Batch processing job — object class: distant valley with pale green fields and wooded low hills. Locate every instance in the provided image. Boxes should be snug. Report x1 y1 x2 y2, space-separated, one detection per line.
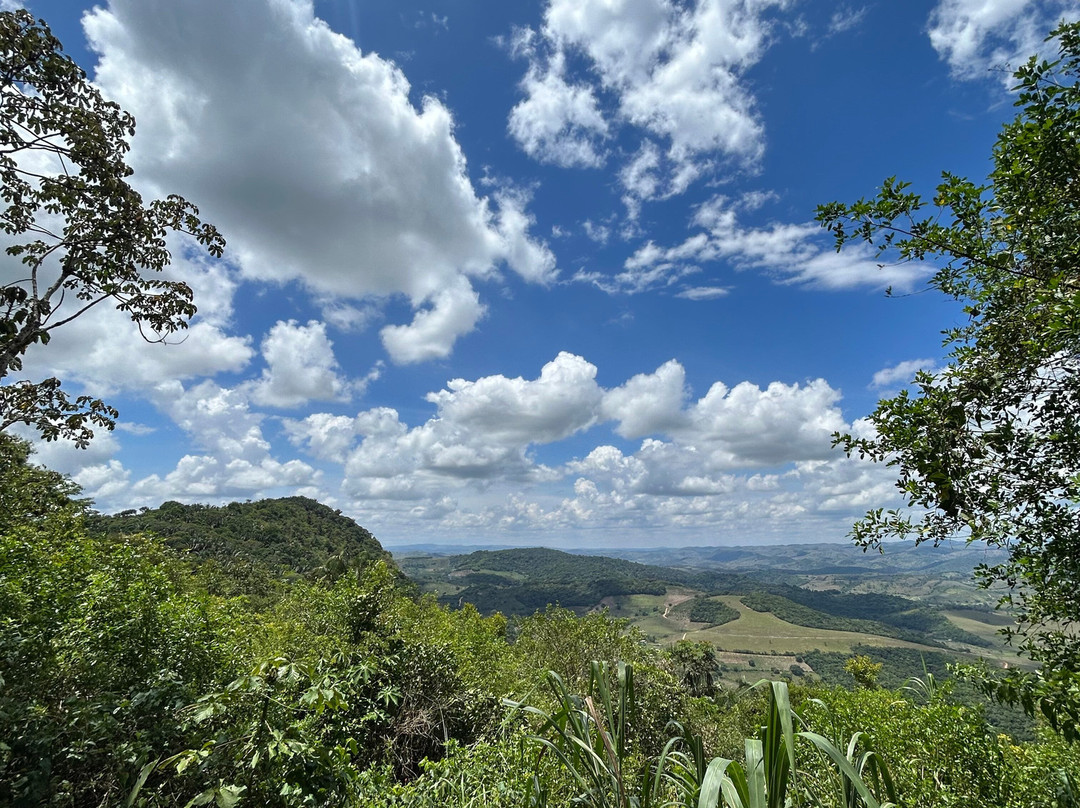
394 544 1026 687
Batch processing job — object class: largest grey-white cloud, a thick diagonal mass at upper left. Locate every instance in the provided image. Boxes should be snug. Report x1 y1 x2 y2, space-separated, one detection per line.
83 0 554 362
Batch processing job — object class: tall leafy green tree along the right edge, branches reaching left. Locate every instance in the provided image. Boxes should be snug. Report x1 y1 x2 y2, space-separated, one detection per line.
819 23 1080 736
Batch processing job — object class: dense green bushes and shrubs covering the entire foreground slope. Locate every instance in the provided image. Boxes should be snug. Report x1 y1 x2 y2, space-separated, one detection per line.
0 436 1080 807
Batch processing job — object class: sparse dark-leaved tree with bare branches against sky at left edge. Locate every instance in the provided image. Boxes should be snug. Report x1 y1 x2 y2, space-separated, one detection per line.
0 11 225 446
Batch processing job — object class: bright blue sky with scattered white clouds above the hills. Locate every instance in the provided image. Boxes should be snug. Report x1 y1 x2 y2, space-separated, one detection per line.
4 0 1077 548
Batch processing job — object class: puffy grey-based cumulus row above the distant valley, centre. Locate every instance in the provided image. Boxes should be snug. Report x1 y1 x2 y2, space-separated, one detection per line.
315 352 845 499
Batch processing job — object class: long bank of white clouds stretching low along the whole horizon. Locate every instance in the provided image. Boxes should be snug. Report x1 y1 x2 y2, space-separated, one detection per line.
54 347 895 542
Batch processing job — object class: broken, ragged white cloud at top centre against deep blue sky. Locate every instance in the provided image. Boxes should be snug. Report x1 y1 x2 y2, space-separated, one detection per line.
510 0 789 203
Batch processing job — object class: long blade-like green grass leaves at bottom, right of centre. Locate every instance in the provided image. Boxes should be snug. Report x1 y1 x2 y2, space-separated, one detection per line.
512 663 896 808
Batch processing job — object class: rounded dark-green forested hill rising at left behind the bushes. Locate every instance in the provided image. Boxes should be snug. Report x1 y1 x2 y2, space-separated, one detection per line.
89 497 393 573
